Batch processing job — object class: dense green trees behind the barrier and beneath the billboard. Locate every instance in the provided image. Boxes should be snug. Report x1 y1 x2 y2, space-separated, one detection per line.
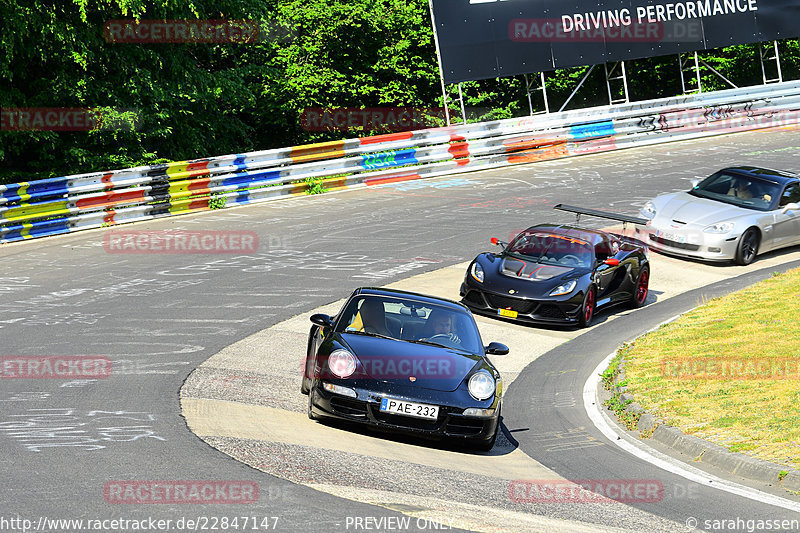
0 0 800 182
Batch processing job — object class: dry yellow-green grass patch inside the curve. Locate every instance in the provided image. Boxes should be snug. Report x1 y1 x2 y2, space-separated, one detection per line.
624 269 800 468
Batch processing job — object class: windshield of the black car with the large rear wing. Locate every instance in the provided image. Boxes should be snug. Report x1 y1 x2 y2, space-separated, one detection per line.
506 231 592 267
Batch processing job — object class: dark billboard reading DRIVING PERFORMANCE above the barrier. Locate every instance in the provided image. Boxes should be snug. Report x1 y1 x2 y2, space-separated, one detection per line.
431 0 800 83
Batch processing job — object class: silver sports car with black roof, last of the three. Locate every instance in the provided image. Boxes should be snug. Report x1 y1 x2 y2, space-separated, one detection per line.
636 166 800 265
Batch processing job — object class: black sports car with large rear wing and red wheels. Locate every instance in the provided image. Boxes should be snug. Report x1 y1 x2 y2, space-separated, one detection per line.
460 204 650 327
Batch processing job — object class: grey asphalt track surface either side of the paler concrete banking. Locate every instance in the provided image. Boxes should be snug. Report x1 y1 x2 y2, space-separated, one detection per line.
0 125 800 531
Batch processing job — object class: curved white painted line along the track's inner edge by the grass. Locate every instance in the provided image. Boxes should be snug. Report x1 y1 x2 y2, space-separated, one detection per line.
583 351 800 512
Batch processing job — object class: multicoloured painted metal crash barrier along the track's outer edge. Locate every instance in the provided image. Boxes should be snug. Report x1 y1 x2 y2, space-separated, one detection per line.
0 81 800 242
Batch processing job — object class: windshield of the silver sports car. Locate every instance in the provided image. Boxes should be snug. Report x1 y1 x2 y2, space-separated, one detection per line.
689 172 781 211
